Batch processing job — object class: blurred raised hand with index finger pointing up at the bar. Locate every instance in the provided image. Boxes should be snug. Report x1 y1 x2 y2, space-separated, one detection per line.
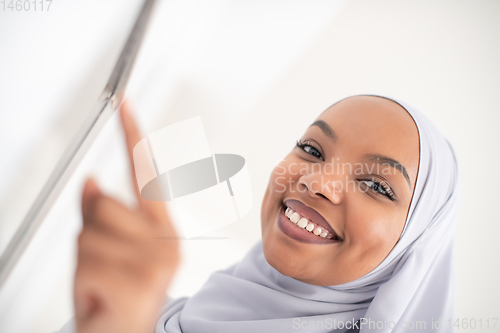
74 102 179 333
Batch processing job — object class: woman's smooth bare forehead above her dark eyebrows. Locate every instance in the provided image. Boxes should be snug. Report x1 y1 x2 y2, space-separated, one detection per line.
313 96 419 182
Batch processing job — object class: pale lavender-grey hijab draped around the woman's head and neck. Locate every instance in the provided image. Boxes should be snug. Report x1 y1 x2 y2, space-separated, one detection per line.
156 96 459 333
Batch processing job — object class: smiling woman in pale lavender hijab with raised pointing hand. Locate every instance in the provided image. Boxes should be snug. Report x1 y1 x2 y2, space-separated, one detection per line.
63 95 459 333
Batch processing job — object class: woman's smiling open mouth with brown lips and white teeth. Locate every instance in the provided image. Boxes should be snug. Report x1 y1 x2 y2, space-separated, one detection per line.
278 199 342 243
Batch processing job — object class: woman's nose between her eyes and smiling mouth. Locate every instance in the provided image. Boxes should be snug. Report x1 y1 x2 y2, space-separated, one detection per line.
297 172 344 205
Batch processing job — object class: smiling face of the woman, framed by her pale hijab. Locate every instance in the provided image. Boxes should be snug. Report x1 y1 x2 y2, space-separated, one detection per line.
261 96 419 286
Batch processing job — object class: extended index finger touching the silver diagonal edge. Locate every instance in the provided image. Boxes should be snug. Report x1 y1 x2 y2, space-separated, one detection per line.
120 100 167 221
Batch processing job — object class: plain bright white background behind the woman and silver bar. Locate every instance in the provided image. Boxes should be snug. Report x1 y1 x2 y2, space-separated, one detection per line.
0 0 500 332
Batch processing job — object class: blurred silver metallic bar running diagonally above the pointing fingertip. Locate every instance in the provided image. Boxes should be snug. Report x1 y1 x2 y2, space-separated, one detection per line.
0 0 156 288
